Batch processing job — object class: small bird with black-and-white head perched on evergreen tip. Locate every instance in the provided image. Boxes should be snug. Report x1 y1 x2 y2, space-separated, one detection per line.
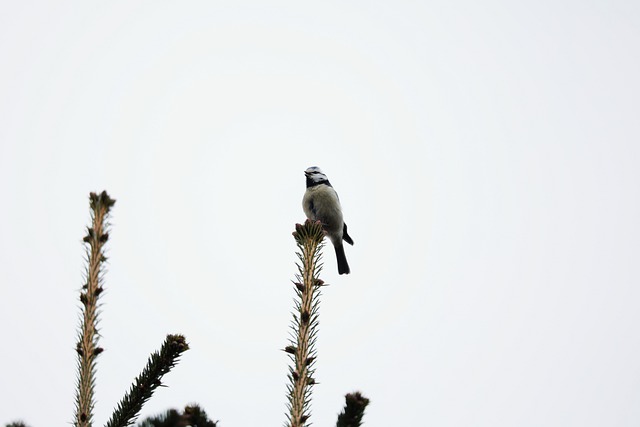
302 166 353 274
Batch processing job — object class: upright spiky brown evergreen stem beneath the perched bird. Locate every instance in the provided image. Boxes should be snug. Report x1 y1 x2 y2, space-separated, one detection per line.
285 220 324 427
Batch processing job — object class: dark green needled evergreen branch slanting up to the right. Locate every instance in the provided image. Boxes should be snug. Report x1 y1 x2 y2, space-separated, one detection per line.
106 335 189 427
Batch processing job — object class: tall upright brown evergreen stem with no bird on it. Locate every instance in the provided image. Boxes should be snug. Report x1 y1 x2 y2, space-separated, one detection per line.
74 191 115 427
